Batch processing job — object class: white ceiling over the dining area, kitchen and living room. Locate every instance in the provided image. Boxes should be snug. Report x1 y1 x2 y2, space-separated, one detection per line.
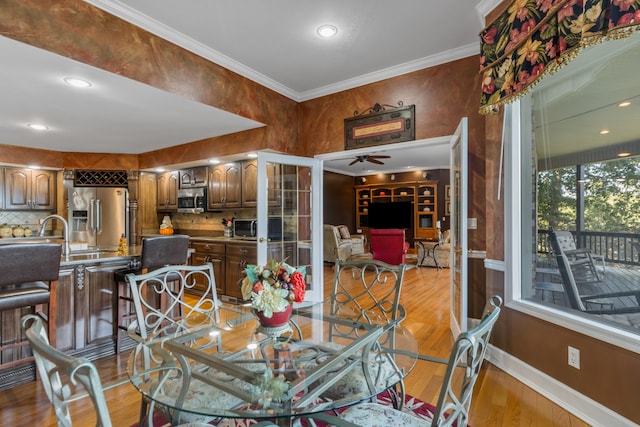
0 0 490 173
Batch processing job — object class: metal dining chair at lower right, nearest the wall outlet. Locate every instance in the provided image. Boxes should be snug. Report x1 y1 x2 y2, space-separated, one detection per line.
309 295 502 427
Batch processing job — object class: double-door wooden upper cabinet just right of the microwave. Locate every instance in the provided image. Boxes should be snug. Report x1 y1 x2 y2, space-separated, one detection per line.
207 162 242 210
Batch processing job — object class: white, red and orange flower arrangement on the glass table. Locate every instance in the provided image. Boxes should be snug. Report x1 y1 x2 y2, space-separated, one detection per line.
242 260 307 318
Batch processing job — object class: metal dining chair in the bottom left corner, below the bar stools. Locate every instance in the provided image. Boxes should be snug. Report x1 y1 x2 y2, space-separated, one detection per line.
22 314 210 427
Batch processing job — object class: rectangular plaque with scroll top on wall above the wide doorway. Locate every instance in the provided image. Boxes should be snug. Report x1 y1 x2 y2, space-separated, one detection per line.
344 104 416 150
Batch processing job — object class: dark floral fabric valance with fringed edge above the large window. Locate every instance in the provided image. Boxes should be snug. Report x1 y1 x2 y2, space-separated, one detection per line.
480 0 640 114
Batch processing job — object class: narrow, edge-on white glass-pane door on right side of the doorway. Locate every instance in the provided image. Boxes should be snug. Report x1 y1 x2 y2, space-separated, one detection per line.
450 117 468 337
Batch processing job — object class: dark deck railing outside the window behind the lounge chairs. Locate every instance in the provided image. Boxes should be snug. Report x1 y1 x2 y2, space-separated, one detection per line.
538 230 640 265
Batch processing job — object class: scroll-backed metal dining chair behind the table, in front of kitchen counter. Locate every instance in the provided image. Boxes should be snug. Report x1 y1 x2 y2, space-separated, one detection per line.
127 263 241 423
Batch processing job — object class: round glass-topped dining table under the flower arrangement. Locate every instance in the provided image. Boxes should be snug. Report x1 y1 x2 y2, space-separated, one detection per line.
127 302 418 425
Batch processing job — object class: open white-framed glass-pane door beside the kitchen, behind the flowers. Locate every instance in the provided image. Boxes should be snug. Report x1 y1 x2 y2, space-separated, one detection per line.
257 152 324 301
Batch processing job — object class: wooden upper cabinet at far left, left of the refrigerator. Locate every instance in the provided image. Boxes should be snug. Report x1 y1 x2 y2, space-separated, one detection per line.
4 168 56 211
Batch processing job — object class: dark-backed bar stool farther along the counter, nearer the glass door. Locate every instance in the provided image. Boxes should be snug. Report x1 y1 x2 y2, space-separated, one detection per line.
114 234 189 353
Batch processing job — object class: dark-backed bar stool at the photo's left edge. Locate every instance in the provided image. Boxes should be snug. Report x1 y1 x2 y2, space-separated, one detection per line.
0 243 62 369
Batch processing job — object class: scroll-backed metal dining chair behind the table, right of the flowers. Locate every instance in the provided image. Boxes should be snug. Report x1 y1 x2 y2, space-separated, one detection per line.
302 259 407 405
